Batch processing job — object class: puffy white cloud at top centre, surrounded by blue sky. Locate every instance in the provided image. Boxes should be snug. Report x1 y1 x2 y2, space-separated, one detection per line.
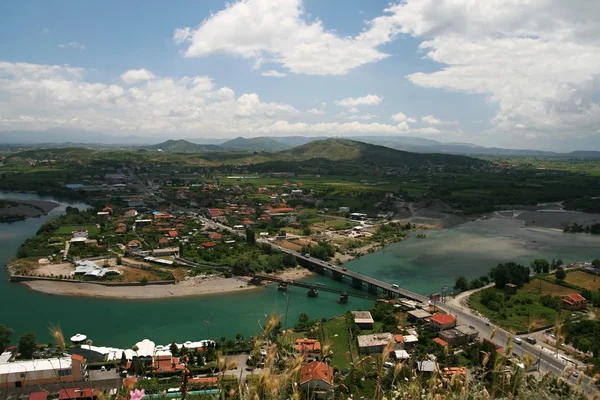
173 0 391 75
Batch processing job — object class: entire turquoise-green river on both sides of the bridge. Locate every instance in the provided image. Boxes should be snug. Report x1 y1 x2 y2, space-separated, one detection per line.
0 193 600 348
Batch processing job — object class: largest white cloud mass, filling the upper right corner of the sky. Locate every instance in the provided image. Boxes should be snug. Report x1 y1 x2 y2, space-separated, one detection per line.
364 0 600 137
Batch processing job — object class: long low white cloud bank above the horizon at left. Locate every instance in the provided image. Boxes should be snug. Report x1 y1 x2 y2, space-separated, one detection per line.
0 62 462 137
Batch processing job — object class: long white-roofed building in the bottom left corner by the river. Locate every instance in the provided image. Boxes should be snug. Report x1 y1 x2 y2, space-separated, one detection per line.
0 355 87 389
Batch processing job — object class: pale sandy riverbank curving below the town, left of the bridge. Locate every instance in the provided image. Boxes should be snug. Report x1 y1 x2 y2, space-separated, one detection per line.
22 267 313 300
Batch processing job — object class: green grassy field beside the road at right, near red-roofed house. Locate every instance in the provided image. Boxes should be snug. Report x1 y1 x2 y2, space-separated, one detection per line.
469 279 573 332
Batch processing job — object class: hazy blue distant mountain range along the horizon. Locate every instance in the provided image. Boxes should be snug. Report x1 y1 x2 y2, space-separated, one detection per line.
0 129 600 158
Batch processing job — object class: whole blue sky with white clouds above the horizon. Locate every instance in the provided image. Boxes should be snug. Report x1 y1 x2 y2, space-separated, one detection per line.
0 0 600 150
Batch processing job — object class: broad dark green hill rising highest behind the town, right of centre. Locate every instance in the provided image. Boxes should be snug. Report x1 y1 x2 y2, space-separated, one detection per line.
277 139 485 167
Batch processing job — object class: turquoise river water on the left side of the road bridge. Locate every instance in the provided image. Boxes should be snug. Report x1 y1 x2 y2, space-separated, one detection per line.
0 193 372 347
